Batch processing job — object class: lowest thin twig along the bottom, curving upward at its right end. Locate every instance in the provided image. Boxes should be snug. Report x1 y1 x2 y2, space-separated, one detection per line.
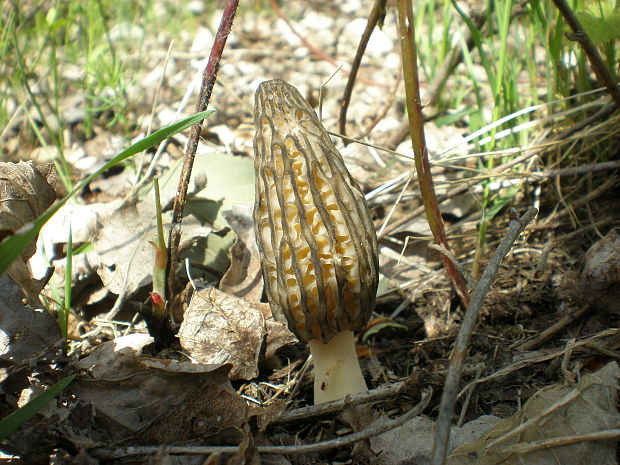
89 389 431 459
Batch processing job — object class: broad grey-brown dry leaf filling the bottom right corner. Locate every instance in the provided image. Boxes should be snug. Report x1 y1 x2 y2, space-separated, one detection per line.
447 362 620 465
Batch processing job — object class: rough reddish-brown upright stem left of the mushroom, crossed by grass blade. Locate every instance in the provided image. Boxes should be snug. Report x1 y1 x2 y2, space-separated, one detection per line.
168 0 239 300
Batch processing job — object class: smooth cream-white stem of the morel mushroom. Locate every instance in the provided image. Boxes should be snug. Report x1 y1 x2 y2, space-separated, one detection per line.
308 331 368 404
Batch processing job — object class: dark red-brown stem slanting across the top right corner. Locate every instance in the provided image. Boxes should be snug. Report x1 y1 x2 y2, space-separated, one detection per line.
553 0 620 107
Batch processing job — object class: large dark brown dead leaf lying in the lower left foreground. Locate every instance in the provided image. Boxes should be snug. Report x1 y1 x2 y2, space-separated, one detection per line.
71 334 251 444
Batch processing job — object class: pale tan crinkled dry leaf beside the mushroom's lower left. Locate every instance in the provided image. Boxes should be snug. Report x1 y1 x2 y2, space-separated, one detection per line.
178 287 295 379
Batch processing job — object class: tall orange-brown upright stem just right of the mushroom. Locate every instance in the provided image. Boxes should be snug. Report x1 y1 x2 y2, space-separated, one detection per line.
398 0 469 308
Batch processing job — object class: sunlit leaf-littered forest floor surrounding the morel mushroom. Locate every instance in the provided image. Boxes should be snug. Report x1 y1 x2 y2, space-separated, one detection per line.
0 0 620 464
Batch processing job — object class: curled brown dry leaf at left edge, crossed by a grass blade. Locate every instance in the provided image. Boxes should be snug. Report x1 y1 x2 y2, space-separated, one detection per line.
0 161 56 304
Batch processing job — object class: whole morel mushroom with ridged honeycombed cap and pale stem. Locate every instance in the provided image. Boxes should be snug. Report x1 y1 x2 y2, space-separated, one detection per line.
254 80 379 404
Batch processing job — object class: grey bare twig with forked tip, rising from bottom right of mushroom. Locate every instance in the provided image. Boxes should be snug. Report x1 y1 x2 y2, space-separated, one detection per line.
432 208 538 465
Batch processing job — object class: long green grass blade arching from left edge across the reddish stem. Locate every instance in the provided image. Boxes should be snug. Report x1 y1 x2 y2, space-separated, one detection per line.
0 110 215 274
